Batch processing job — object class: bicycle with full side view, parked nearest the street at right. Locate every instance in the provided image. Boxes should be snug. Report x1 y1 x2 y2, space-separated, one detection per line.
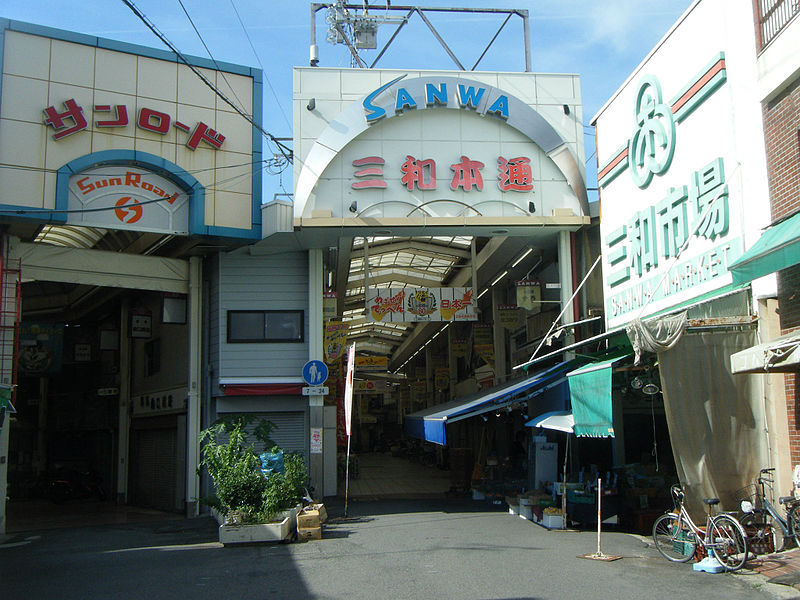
653 484 747 571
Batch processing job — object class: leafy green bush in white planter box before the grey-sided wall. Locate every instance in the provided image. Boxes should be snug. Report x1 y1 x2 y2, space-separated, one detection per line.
199 415 308 543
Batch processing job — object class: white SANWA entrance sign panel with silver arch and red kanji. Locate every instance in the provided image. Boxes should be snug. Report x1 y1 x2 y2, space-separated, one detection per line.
294 70 588 219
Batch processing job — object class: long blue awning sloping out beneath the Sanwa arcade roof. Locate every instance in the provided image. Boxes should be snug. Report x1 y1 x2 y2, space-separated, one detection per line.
404 359 585 446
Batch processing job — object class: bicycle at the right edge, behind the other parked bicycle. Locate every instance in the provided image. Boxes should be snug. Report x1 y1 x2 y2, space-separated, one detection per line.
737 468 800 554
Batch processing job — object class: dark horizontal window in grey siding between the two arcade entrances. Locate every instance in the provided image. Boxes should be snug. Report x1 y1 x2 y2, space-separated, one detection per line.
228 310 303 343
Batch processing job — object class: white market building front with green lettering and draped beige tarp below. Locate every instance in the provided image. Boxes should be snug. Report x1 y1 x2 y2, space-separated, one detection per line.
593 0 788 509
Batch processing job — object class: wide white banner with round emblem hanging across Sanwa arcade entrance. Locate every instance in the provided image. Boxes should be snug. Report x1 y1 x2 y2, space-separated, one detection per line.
366 288 478 323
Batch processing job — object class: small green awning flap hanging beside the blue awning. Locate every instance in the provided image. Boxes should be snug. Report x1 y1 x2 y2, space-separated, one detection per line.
567 353 631 437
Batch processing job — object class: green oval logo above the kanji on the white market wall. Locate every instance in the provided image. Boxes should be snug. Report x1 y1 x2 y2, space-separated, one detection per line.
628 75 675 188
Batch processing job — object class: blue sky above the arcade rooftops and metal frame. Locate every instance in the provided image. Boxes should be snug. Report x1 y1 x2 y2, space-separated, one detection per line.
0 0 692 200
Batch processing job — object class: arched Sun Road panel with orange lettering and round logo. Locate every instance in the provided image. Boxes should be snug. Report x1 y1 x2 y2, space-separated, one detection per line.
68 166 189 234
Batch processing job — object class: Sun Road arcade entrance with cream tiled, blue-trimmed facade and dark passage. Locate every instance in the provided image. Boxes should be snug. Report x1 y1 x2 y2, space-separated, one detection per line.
0 20 261 531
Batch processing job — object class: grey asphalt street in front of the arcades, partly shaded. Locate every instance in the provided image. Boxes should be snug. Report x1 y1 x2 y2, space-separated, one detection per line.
0 500 796 600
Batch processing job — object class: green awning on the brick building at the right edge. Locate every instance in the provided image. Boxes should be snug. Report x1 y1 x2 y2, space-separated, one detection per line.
728 213 800 284
